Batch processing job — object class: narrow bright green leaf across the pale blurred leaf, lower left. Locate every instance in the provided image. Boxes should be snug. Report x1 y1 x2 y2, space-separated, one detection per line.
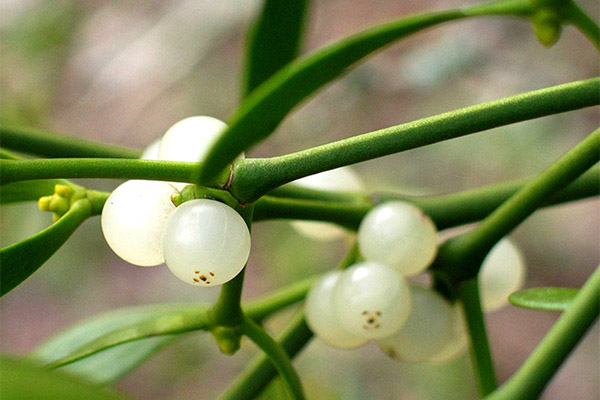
39 304 210 368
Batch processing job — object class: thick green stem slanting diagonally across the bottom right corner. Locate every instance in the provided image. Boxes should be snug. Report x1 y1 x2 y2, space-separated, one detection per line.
486 268 600 400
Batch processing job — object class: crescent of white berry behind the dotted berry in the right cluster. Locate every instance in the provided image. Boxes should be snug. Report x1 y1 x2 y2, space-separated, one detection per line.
304 271 369 349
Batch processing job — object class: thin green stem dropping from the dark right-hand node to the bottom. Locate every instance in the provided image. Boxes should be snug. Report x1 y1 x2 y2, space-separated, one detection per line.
458 278 498 396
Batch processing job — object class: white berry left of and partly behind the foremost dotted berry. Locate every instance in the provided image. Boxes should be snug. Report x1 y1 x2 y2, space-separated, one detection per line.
101 180 176 267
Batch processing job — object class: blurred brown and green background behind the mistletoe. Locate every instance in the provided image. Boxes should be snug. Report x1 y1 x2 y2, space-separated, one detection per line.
0 0 600 400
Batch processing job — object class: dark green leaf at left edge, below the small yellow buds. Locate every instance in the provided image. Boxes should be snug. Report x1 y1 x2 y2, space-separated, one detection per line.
0 199 92 296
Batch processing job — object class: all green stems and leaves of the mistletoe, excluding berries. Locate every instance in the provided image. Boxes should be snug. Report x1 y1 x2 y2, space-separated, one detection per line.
0 0 600 400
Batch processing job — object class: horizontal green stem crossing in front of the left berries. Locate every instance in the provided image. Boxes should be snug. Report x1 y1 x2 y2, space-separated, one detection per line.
0 158 206 185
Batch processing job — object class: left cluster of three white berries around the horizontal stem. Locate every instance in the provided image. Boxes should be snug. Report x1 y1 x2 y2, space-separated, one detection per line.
102 116 250 286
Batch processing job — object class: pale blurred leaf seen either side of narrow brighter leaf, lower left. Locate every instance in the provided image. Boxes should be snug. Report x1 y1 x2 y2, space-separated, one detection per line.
31 304 206 384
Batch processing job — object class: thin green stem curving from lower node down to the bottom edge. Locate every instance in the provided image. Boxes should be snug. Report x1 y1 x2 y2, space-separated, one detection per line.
243 318 304 400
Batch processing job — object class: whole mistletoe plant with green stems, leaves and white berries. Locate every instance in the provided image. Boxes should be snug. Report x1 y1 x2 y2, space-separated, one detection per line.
0 0 600 400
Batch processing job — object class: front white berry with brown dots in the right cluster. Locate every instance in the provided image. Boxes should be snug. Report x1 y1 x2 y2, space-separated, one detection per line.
333 262 411 339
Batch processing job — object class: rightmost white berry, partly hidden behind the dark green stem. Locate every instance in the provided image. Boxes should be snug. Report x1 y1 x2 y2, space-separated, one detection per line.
479 238 525 312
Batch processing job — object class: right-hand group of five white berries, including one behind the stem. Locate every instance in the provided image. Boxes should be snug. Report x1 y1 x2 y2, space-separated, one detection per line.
305 189 524 362
